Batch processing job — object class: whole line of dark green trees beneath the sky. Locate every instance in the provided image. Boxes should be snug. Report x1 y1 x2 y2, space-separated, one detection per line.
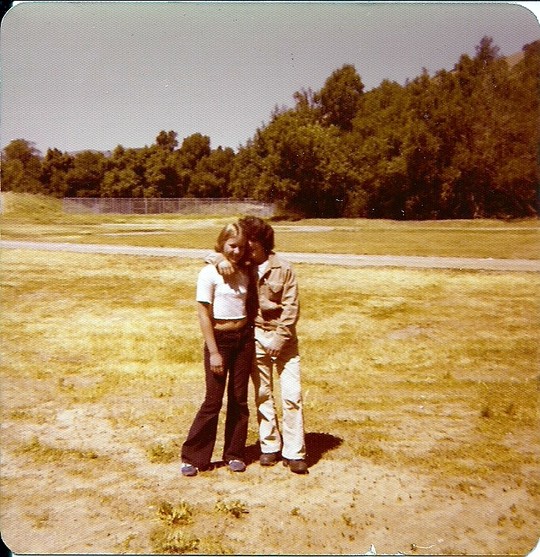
2 37 540 220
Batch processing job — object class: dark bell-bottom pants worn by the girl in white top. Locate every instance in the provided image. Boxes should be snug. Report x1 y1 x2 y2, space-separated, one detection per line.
182 327 255 470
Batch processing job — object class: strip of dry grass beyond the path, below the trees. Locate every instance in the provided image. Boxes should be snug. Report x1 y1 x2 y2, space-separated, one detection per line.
1 192 540 260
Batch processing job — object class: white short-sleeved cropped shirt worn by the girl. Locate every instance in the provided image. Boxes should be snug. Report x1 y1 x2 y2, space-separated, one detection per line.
197 264 249 319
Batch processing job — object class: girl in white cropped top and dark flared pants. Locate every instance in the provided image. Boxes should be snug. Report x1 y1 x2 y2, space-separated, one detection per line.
182 223 255 476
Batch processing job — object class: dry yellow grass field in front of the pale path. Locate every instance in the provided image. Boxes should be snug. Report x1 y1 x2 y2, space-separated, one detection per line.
0 229 540 555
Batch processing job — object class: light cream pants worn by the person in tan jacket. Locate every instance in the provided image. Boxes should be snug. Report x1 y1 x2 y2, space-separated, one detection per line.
252 328 306 460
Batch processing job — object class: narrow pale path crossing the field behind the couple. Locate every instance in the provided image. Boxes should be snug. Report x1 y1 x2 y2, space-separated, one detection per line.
0 240 540 272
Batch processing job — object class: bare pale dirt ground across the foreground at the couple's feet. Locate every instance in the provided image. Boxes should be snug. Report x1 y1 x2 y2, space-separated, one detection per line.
2 385 539 555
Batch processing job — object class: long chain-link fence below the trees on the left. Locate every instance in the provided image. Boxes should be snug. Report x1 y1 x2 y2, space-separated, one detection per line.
63 197 276 218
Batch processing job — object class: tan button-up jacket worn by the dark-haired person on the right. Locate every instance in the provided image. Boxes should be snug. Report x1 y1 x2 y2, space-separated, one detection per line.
255 252 300 344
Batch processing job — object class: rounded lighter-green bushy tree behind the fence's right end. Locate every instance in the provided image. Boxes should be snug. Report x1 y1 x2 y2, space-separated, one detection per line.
231 102 353 217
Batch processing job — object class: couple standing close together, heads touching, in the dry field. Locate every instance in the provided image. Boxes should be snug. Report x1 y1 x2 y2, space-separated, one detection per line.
182 216 308 476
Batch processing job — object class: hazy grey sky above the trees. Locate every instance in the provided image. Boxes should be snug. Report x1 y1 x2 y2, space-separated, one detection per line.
0 1 540 155
